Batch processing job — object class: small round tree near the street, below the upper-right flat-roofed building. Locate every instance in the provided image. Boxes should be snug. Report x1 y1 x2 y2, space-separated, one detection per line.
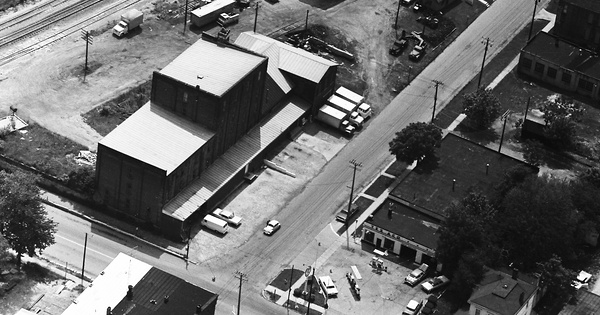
463 89 500 129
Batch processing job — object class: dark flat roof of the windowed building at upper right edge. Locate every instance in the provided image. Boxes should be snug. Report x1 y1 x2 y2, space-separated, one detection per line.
522 32 600 79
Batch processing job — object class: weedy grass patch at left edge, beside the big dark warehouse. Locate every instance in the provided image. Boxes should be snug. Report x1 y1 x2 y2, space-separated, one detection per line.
1 123 87 177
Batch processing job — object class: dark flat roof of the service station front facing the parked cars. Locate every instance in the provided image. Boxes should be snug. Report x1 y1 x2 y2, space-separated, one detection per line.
367 196 440 250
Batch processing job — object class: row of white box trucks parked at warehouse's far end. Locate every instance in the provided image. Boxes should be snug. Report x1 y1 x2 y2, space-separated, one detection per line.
317 86 373 136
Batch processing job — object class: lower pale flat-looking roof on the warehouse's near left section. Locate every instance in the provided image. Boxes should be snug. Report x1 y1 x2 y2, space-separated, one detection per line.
100 102 214 175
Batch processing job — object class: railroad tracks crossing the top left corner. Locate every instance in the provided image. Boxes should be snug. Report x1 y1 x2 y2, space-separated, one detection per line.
0 0 142 66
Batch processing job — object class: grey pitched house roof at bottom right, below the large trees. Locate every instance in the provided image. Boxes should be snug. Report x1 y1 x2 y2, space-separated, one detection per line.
469 269 537 315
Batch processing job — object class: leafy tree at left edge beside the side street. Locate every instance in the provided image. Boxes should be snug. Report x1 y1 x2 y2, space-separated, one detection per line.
0 171 56 266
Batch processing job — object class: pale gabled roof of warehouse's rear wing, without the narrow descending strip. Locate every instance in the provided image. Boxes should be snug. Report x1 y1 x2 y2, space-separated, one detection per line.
235 32 337 82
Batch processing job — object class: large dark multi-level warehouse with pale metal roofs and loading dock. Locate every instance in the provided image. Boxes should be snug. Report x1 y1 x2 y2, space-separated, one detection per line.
96 33 337 239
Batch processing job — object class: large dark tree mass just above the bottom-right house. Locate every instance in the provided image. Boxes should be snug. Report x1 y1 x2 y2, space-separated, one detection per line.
494 176 578 268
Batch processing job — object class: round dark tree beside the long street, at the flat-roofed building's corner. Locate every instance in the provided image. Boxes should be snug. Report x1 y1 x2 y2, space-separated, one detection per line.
390 122 442 164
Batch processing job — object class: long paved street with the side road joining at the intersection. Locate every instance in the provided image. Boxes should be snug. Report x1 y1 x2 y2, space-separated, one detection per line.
39 0 547 314
